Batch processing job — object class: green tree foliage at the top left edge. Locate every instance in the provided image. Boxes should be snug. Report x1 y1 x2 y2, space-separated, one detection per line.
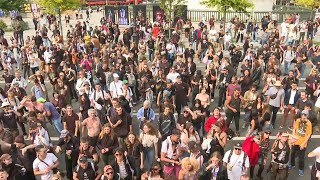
36 0 81 14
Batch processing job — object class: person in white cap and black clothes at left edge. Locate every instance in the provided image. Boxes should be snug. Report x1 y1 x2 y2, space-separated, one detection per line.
0 101 21 138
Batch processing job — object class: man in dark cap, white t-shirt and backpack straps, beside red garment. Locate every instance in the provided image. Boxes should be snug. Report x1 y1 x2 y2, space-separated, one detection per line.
223 143 250 179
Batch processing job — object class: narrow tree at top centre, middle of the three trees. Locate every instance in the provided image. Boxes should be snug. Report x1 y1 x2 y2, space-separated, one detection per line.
159 0 186 35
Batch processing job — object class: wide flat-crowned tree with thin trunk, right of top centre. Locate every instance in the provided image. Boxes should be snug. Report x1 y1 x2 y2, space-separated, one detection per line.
201 0 254 32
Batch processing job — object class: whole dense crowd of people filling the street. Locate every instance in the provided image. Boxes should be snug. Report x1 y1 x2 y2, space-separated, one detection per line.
0 8 320 180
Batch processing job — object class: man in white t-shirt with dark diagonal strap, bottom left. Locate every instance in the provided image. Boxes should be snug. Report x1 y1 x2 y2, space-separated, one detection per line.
32 145 59 180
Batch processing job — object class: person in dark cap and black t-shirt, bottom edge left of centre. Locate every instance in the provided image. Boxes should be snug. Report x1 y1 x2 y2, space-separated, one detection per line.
73 156 102 180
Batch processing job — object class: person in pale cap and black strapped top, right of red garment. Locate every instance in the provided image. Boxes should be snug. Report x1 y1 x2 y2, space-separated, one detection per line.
267 132 291 180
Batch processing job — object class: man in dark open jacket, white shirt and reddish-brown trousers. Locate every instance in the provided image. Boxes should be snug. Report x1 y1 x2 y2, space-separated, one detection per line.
279 81 300 129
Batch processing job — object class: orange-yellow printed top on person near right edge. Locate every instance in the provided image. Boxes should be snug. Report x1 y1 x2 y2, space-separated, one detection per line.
293 118 312 146
